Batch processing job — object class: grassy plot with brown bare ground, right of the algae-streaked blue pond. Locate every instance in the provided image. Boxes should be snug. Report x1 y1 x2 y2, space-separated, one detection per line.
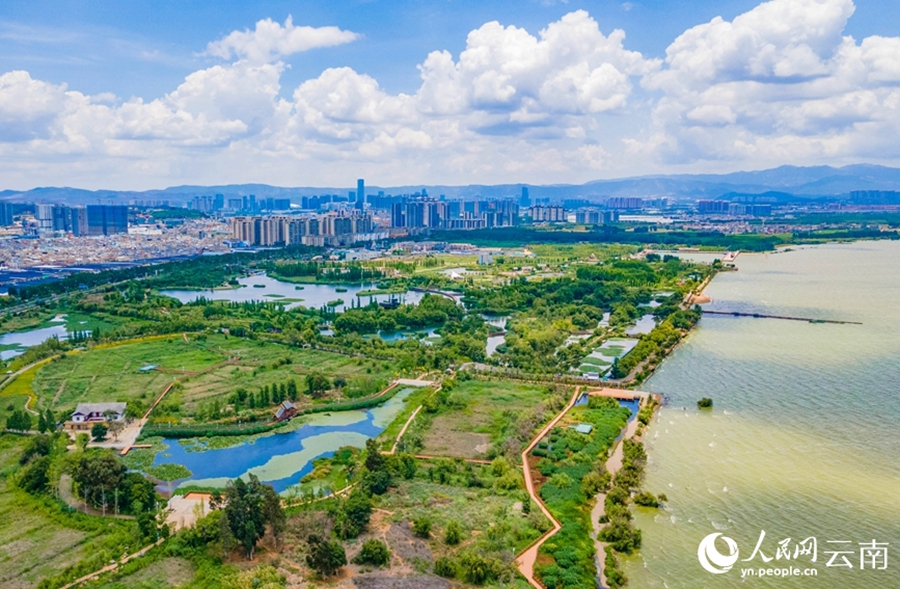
422 380 547 458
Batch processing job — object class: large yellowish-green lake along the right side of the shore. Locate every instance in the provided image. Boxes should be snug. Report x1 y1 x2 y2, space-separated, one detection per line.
625 242 900 589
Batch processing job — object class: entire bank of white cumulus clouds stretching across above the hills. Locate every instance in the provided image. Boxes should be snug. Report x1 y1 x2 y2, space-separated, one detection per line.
0 0 900 187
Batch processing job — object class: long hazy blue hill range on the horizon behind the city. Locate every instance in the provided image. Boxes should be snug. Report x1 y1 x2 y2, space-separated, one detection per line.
0 164 900 204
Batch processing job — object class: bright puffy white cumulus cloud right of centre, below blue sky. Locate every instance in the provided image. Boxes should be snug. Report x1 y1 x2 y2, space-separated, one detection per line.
417 10 658 123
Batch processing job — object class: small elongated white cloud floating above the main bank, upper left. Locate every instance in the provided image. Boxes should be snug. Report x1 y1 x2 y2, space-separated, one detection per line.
206 16 359 63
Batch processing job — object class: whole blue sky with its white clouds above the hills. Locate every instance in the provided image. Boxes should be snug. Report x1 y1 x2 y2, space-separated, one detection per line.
0 0 900 188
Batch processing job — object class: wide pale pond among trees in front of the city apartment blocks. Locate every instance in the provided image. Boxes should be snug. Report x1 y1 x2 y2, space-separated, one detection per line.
160 274 424 311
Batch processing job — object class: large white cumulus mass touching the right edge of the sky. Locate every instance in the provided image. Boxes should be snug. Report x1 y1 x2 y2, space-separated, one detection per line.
632 0 900 163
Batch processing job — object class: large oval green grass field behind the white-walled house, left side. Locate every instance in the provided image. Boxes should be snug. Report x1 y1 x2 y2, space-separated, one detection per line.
29 335 392 416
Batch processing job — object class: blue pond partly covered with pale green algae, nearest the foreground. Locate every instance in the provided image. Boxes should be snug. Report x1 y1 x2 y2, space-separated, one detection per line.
153 387 415 493
